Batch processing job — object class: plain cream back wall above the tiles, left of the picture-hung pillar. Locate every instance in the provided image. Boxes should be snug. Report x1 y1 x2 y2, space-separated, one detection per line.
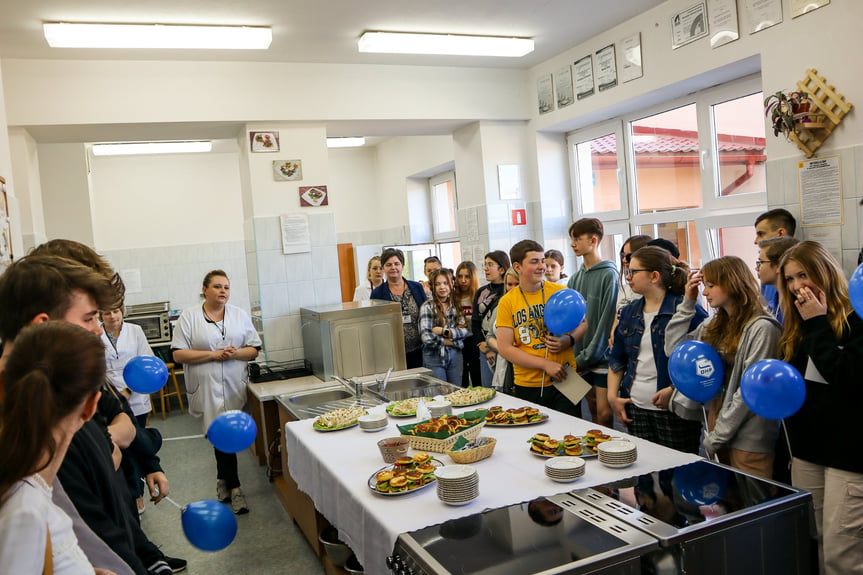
90 140 243 250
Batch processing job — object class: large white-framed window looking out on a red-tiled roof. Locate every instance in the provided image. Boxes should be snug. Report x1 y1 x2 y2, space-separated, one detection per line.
567 73 767 267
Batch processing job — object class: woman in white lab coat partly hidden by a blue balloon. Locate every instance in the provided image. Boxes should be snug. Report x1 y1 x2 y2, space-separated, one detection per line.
99 307 153 427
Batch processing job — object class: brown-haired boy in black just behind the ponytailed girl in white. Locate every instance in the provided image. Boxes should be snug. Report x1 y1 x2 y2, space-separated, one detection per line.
0 255 186 575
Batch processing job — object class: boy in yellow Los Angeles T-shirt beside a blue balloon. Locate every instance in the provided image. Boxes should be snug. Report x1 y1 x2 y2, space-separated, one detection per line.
496 240 587 417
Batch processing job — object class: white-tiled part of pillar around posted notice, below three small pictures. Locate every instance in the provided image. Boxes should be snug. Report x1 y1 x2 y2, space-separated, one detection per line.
246 212 342 362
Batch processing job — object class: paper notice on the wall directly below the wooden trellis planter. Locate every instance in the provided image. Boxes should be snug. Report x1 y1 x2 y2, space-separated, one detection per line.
797 156 842 228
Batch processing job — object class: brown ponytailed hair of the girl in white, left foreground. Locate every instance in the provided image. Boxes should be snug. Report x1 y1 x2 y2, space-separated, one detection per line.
0 321 105 504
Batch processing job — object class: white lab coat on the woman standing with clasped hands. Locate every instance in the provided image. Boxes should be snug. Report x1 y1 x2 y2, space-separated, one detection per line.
171 304 261 433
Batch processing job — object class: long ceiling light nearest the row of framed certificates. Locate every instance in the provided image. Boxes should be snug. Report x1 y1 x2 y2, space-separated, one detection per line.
357 32 533 58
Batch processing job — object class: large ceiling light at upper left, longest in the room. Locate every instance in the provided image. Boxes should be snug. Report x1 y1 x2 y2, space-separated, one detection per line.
43 22 273 50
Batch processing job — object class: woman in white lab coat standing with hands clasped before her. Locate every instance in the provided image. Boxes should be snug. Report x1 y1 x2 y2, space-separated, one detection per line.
171 270 261 515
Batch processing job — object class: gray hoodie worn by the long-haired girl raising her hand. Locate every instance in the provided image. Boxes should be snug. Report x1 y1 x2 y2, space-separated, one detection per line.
665 299 782 453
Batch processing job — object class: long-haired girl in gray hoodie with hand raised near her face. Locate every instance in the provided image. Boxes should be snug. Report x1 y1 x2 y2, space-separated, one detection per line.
665 256 782 479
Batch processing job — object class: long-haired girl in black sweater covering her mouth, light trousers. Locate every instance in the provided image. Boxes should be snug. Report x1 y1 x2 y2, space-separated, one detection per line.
777 241 863 575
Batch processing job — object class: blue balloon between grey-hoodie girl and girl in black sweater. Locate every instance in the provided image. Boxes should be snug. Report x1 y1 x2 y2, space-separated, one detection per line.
740 359 806 419
